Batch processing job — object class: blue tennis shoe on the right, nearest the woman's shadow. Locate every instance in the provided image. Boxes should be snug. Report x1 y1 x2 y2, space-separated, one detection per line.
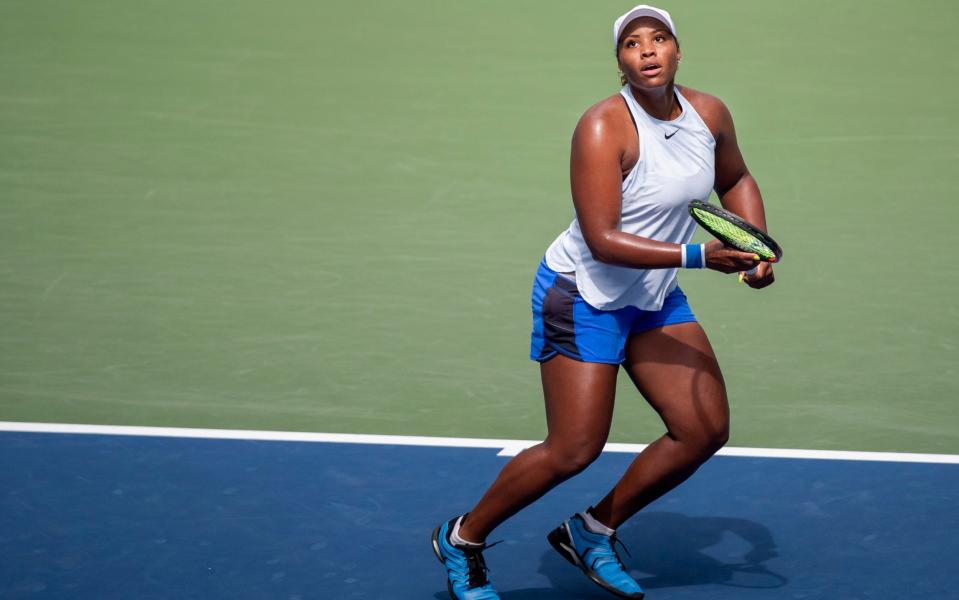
546 514 644 600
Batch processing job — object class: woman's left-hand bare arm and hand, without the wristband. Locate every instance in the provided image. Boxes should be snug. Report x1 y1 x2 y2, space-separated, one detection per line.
570 96 755 273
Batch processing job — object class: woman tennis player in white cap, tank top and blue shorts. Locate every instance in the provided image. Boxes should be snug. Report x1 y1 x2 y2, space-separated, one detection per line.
433 5 773 600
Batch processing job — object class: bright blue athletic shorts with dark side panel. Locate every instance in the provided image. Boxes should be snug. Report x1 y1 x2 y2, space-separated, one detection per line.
529 258 696 365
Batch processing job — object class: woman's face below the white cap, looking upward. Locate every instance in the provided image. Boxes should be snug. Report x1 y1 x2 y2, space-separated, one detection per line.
616 17 682 88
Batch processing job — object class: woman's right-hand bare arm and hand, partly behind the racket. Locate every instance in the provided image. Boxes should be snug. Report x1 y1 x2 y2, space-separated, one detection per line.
708 98 775 289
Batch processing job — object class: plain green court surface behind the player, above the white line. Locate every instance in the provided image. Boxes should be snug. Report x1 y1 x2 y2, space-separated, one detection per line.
0 0 959 453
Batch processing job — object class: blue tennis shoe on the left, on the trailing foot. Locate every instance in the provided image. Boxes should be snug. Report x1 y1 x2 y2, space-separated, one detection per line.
433 515 500 600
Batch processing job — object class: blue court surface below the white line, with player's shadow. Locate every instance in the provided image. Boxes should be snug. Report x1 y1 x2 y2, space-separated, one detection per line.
0 432 959 600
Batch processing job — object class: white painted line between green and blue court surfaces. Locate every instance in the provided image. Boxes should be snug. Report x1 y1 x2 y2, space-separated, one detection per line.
0 421 959 465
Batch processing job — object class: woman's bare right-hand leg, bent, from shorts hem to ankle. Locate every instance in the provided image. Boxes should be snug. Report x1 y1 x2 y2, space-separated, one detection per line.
590 323 729 529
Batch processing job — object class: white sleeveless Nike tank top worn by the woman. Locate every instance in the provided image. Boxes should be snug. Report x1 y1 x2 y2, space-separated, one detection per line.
546 86 716 310
